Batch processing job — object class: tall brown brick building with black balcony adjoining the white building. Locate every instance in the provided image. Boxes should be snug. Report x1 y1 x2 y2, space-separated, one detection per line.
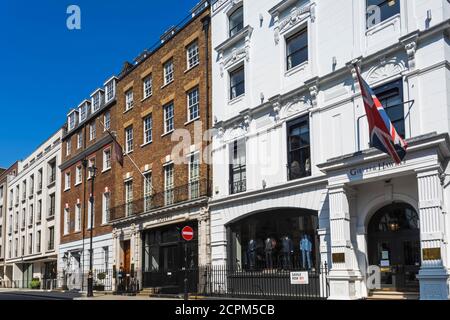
111 1 211 292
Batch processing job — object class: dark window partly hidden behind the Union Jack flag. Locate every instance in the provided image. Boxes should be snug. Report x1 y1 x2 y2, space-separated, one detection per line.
374 80 405 138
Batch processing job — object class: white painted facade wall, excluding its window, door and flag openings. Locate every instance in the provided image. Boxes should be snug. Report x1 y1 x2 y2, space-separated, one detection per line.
210 0 450 299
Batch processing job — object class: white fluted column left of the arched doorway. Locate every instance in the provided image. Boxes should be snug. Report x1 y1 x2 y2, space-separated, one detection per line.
328 185 363 300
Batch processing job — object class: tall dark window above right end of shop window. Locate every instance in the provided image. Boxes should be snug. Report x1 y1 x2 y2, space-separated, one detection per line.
287 116 311 180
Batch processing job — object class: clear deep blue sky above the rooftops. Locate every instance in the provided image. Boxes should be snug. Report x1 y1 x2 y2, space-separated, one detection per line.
0 0 198 167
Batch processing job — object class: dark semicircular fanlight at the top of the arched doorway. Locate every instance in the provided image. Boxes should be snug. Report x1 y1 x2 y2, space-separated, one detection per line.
369 203 419 233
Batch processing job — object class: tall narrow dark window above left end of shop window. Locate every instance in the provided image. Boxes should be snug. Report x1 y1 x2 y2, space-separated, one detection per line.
230 139 247 194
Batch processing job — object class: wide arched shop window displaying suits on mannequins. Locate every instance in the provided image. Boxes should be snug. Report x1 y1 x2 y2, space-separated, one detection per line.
228 209 320 270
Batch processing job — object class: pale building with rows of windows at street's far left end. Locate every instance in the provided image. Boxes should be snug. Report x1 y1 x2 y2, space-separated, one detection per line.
4 130 62 288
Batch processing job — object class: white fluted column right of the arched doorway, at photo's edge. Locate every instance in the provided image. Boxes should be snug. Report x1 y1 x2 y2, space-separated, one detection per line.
416 168 449 300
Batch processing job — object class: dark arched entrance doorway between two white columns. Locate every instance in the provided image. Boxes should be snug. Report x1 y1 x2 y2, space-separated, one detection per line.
368 203 421 291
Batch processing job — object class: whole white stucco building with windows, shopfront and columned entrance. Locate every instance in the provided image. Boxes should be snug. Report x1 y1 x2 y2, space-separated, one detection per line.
210 0 450 299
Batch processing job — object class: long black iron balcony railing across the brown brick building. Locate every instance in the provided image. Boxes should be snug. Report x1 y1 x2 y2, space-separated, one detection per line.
110 179 209 221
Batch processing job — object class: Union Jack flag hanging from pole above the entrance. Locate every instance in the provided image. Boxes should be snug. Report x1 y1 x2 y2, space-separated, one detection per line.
355 66 408 164
